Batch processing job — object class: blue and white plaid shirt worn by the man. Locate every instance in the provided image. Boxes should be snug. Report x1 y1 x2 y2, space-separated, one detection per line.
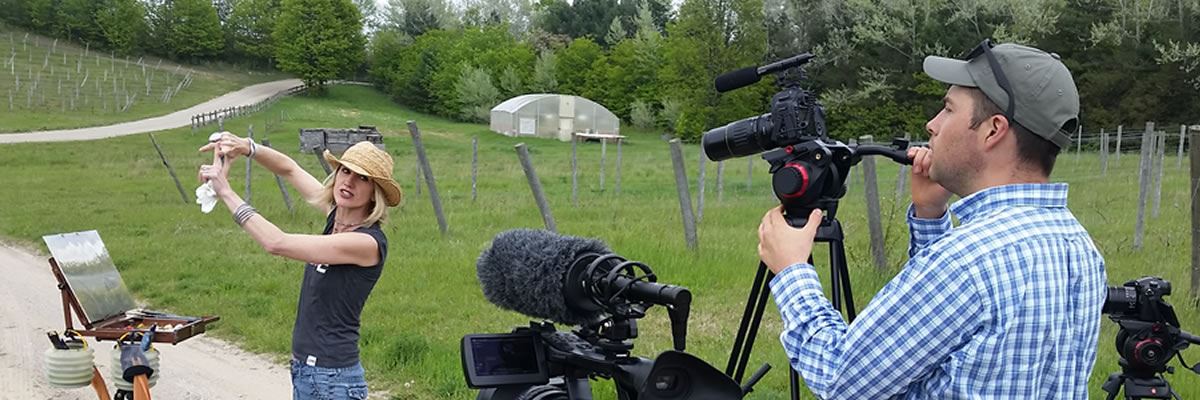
770 184 1106 399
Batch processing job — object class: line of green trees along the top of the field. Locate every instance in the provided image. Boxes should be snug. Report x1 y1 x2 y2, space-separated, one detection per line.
0 0 1200 139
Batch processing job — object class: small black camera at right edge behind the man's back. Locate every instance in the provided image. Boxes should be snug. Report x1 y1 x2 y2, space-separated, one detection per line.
1102 276 1200 400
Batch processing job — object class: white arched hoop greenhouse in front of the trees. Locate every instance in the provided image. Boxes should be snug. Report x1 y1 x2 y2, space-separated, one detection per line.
491 94 620 142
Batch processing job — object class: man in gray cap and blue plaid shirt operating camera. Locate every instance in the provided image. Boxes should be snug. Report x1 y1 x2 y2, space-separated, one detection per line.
758 41 1106 399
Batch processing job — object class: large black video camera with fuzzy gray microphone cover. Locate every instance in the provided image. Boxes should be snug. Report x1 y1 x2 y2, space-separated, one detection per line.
462 229 754 400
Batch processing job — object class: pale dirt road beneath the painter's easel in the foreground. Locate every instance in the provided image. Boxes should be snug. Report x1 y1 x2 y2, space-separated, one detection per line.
0 244 292 400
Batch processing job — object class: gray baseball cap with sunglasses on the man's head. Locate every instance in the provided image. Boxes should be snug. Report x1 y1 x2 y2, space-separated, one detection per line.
924 41 1079 149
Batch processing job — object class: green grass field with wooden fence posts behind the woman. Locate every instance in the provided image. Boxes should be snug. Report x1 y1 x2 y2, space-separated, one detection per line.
0 86 1200 400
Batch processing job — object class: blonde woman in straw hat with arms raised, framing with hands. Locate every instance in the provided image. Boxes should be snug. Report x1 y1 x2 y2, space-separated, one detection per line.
200 132 402 399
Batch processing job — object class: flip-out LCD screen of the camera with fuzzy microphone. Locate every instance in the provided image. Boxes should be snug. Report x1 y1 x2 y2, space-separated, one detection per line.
462 334 548 388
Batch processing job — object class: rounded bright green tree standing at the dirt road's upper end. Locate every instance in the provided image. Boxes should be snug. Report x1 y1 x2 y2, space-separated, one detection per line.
272 0 366 91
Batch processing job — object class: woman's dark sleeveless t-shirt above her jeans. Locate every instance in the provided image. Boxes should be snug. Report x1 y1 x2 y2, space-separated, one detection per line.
292 210 388 368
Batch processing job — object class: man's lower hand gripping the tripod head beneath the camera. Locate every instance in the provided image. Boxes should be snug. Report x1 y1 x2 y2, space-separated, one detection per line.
758 205 821 274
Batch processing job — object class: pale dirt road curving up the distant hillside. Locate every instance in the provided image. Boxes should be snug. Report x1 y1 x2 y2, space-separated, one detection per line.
0 79 304 144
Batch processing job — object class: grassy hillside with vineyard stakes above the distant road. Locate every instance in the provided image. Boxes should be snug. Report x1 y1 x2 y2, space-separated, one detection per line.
0 24 286 132
